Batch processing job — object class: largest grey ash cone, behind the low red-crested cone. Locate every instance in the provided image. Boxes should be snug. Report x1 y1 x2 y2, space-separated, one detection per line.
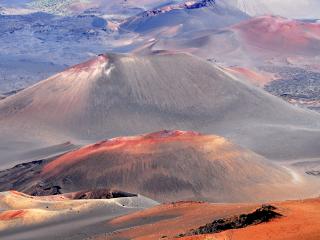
0 52 320 163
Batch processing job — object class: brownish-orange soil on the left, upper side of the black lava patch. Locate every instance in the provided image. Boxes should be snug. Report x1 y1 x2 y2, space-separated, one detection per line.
104 202 257 240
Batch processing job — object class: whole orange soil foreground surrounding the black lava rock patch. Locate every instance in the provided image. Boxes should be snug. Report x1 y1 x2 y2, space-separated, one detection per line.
102 199 320 240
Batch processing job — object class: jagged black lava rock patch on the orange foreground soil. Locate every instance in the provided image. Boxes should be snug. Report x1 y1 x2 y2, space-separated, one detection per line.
179 205 282 237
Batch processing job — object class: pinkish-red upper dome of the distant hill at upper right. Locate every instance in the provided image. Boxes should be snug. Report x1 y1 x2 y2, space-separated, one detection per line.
233 16 320 55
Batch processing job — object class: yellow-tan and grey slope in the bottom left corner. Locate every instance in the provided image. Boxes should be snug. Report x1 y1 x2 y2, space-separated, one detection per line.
0 191 157 240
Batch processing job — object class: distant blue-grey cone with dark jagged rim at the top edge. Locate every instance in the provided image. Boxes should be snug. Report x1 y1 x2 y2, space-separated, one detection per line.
120 0 249 34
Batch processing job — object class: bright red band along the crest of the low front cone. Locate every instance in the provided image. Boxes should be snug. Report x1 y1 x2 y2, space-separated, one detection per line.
42 130 200 175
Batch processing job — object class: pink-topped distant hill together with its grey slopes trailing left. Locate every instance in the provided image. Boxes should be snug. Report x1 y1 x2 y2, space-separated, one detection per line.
148 16 320 64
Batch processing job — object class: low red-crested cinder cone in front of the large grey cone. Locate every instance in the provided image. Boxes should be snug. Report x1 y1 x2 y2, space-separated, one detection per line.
0 131 304 202
